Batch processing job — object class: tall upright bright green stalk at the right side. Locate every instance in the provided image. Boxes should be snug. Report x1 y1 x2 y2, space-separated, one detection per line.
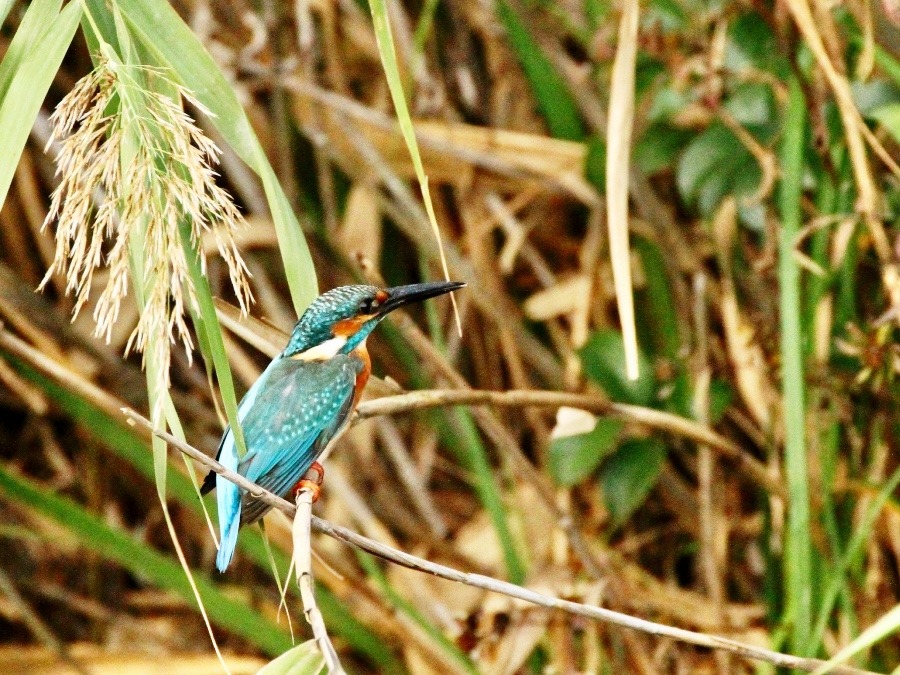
778 78 813 654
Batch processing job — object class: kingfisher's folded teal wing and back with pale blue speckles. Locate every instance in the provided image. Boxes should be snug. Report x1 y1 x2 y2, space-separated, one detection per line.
238 354 362 522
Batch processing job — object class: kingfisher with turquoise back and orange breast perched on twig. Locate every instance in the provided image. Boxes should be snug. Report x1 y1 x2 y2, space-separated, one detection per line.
200 281 465 572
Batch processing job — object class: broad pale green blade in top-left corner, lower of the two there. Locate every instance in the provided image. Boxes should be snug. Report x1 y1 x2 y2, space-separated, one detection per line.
0 2 81 205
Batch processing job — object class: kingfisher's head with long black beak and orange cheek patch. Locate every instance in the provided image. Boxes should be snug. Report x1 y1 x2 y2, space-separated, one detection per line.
283 281 465 360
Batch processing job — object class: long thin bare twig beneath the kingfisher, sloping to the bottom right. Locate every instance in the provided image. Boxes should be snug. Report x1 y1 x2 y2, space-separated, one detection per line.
122 408 876 675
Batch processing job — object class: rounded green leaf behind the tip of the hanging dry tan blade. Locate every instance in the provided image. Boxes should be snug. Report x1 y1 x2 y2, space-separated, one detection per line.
578 329 656 406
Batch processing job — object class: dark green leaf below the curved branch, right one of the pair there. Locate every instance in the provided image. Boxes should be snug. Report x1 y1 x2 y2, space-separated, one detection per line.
600 438 666 526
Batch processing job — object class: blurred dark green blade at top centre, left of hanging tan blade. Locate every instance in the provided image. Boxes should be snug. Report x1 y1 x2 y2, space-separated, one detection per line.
497 0 585 141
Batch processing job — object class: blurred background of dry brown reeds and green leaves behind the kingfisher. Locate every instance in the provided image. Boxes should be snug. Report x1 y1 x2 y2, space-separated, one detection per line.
0 0 900 674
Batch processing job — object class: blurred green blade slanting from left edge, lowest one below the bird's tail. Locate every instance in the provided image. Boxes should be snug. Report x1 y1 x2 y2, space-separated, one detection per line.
0 466 291 656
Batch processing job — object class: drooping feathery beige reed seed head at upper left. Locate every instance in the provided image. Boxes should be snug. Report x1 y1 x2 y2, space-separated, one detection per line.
41 57 253 386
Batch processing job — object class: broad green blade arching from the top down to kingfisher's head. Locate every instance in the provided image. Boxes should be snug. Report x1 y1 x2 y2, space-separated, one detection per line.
116 0 318 316
